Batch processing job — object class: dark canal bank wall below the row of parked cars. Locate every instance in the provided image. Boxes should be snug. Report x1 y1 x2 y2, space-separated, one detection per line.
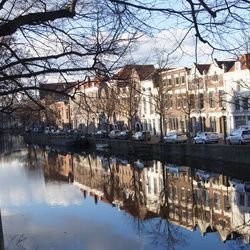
88 138 250 164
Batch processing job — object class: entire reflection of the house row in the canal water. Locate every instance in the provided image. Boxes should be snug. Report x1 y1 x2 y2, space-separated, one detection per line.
41 150 250 242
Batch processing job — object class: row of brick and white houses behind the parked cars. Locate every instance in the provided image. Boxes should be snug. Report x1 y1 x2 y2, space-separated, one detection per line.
37 54 250 136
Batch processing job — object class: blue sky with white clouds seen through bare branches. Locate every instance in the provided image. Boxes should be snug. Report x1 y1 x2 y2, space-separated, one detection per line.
8 0 250 82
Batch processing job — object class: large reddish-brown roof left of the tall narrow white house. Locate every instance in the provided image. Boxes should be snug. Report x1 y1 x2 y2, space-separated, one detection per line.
113 64 155 81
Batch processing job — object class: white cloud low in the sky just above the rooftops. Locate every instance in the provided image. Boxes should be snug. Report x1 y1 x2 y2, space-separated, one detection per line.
131 29 229 67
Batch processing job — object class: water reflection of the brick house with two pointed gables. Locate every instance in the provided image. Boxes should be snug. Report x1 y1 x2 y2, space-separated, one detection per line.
193 170 232 241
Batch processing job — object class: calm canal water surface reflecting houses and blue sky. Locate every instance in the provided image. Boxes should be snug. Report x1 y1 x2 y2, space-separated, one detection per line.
0 137 250 250
